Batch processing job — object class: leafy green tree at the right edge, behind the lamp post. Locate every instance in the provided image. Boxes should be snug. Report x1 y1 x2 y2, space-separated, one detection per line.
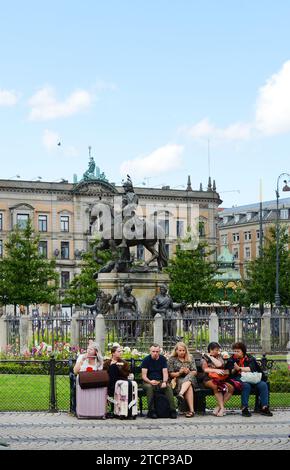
244 226 290 305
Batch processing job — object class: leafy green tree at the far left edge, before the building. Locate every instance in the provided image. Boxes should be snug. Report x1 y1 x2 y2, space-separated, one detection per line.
0 221 59 307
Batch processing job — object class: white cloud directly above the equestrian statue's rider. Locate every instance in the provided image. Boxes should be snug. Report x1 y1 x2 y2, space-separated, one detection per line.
120 144 184 178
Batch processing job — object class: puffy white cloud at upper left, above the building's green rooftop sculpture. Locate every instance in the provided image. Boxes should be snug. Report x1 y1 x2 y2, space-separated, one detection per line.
29 87 94 121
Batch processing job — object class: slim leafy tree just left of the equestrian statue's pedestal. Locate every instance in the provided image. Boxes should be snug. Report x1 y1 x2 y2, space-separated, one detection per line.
63 240 112 305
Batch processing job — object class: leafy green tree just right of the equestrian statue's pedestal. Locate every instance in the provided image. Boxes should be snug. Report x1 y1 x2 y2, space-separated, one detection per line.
166 243 217 304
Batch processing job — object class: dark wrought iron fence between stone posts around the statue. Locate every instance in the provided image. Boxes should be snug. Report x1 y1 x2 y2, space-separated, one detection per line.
5 307 290 353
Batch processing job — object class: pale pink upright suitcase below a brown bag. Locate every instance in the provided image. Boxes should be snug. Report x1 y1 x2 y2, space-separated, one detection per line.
76 377 108 419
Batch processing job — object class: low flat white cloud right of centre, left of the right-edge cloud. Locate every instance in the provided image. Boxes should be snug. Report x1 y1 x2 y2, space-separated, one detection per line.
182 118 251 141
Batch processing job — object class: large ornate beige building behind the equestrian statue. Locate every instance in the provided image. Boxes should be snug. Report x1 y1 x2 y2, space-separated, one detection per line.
0 158 221 310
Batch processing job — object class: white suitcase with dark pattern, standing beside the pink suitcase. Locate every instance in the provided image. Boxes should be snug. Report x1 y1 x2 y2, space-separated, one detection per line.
113 380 138 419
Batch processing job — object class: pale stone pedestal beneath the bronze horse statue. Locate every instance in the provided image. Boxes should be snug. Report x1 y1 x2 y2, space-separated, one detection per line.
97 272 169 316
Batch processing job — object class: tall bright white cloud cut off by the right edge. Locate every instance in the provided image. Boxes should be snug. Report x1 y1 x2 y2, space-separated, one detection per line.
256 60 290 135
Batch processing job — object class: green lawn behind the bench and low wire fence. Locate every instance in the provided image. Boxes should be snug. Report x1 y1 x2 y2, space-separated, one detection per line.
0 374 290 411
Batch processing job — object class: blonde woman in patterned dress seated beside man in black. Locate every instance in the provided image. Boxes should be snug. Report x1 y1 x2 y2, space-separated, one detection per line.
168 343 197 418
